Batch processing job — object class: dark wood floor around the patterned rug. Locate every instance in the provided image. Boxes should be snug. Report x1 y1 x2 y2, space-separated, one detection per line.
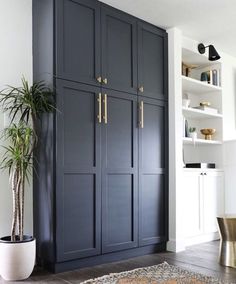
0 241 236 284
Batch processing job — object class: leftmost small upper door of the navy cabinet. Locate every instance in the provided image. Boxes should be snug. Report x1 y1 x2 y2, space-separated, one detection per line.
56 0 101 85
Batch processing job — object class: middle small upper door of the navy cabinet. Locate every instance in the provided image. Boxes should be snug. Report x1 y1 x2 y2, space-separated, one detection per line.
101 6 137 94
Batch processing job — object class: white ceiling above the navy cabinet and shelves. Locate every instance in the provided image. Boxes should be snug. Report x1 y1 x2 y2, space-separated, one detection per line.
100 0 236 57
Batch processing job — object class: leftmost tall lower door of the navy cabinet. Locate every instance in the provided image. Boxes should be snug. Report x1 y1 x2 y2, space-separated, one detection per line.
56 80 101 261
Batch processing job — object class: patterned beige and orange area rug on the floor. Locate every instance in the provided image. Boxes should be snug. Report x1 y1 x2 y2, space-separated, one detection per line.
81 262 227 284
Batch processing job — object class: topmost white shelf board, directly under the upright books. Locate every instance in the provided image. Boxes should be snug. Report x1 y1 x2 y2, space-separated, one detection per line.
182 75 222 94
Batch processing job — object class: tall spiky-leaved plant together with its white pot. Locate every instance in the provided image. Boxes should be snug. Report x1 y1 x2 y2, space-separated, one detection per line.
0 78 54 280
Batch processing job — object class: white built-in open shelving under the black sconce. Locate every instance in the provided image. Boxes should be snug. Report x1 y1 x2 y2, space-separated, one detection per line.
181 48 223 168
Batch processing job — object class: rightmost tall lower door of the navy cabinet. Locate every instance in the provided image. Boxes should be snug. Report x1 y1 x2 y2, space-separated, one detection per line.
139 98 168 246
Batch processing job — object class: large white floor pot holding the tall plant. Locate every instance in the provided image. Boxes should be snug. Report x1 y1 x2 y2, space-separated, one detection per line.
0 238 36 281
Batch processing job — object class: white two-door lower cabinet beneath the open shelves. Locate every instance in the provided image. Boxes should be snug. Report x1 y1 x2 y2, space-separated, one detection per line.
183 170 224 245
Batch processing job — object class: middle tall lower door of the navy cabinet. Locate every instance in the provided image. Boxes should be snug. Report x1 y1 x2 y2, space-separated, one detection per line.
102 90 137 253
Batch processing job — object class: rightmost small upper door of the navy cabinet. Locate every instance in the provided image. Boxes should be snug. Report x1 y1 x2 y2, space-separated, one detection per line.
138 22 168 100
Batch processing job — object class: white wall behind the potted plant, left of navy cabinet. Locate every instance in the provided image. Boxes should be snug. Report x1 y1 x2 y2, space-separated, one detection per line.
0 0 33 236
